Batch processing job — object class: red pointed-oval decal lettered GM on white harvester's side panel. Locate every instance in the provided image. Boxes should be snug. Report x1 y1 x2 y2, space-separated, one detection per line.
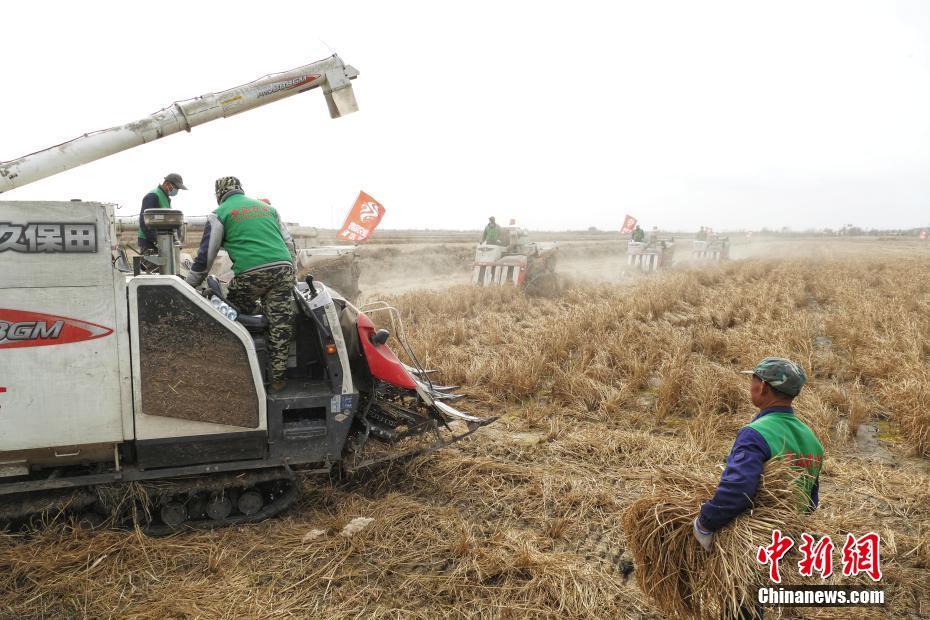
0 308 113 349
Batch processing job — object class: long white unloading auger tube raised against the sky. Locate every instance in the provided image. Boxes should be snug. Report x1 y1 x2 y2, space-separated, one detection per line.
0 55 358 194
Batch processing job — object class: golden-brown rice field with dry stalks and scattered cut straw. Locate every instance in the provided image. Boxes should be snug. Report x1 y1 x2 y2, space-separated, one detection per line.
0 253 930 618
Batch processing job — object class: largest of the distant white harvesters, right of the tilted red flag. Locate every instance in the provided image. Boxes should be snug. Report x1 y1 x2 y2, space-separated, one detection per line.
472 226 557 286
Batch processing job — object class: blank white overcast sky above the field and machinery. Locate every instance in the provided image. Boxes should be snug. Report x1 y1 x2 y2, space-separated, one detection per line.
0 0 930 230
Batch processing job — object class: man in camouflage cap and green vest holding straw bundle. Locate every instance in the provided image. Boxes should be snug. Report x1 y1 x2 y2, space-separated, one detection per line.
694 357 823 551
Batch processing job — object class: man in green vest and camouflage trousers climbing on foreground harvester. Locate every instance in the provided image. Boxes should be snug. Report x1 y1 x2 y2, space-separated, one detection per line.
187 177 297 391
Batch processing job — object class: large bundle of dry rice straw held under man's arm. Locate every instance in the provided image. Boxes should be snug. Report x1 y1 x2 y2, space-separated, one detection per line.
623 459 808 618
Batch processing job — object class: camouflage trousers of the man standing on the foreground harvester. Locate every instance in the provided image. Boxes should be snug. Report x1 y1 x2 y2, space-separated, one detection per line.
226 265 294 381
